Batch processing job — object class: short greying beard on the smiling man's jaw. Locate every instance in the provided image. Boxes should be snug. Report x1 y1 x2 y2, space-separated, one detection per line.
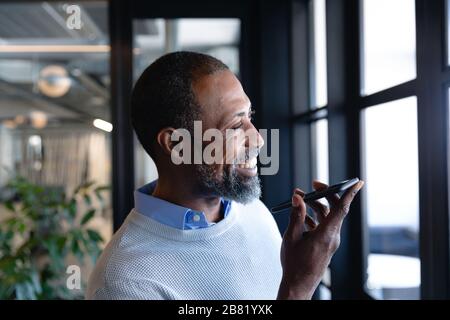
195 164 261 204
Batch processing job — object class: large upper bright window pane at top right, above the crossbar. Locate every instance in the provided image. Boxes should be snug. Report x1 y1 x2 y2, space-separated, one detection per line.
361 0 416 95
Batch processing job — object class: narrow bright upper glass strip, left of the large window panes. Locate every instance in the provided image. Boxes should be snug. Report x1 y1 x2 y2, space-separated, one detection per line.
309 0 328 108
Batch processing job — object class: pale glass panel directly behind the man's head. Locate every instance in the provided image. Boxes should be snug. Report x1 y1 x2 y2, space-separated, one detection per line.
133 18 241 187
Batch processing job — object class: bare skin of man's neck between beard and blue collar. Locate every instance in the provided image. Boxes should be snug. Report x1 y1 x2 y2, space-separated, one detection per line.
152 179 223 222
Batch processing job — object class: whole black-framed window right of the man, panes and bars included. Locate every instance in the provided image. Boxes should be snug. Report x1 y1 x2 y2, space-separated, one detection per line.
291 0 450 299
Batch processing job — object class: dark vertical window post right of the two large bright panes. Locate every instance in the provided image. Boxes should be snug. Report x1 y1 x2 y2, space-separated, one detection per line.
416 0 450 299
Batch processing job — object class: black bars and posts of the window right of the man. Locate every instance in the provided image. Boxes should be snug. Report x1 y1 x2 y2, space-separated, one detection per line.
291 0 450 299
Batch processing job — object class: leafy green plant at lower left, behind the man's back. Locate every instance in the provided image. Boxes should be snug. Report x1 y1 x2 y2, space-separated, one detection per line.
0 177 108 299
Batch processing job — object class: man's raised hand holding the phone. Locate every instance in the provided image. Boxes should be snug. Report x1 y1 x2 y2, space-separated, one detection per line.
278 181 364 299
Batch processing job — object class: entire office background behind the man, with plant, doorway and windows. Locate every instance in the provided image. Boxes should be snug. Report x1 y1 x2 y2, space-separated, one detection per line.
0 0 450 299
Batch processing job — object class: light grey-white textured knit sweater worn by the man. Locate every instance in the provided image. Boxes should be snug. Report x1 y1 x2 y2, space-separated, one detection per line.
86 200 281 300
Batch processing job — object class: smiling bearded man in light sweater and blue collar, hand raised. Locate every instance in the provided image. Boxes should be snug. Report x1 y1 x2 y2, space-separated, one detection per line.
87 52 363 299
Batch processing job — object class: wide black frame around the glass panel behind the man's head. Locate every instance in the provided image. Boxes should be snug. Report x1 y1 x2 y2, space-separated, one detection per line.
109 0 292 238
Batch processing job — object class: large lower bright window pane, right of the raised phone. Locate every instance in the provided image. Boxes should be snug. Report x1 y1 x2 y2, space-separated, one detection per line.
362 97 420 299
